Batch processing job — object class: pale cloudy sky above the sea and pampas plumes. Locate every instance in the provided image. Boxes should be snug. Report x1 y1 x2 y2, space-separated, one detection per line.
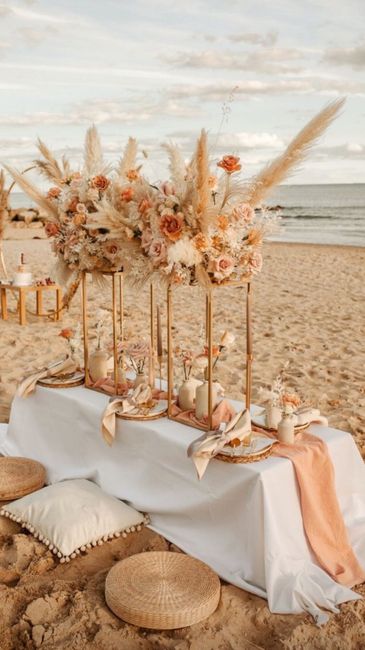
0 0 365 183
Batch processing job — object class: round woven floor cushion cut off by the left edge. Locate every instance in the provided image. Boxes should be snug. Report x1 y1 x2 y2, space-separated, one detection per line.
0 456 46 501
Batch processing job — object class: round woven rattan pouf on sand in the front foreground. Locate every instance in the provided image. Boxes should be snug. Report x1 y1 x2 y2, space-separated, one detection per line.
105 551 220 630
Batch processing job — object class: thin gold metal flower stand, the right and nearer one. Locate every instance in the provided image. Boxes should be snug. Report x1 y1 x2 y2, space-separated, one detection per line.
167 280 253 431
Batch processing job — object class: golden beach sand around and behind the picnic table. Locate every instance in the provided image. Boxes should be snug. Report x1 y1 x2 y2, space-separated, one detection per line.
0 233 365 650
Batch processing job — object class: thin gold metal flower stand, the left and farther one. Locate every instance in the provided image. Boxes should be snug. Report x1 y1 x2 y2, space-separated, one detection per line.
81 270 155 397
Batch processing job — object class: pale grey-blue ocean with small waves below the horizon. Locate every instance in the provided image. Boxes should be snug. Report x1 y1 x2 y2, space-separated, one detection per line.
10 183 365 246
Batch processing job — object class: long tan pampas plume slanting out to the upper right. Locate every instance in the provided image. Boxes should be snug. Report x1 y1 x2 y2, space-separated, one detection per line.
242 99 345 207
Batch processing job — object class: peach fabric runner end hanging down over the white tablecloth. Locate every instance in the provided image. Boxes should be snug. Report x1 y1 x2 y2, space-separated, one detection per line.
273 431 365 588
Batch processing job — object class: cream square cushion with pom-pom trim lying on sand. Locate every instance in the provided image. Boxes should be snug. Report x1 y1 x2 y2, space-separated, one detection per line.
0 479 147 562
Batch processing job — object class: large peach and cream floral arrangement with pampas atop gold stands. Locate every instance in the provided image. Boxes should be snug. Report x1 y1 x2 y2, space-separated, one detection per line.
7 100 343 302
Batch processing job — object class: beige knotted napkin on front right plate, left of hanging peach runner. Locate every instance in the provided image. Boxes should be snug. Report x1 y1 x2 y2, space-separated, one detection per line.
188 402 251 480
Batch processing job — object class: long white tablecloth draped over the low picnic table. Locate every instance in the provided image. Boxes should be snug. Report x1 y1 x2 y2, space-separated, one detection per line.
0 387 365 623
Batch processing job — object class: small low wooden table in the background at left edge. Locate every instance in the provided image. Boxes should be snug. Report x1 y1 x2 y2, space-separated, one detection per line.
0 284 62 325
